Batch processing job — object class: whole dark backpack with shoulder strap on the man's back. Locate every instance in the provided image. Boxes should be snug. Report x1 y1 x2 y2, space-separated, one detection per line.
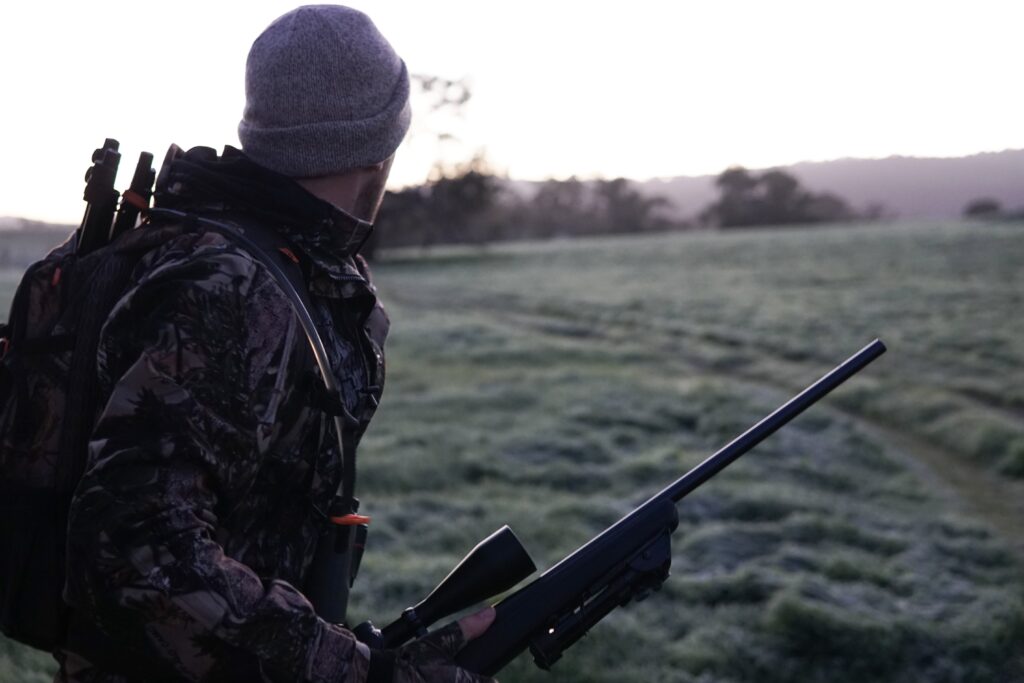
0 140 365 651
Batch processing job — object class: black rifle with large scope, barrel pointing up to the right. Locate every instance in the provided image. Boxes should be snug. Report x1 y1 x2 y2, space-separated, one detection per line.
356 340 886 676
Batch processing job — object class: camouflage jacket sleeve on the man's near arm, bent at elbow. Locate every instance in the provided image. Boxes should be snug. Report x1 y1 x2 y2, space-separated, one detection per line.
66 242 370 683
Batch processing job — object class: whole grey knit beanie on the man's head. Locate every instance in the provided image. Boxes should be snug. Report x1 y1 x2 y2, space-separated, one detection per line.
239 5 412 177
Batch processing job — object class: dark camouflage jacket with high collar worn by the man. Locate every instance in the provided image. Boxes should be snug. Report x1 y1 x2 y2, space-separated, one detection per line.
58 148 388 683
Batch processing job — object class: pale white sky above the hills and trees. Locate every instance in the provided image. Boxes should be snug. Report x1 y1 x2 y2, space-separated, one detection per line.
0 0 1024 223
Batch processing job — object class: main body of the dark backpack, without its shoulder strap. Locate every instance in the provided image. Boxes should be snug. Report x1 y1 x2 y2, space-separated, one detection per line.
0 220 174 649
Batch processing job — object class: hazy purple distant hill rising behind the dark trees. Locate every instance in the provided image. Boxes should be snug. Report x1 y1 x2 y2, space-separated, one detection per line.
639 150 1024 218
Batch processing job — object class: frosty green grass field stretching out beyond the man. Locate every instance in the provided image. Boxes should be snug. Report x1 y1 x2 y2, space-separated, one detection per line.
0 224 1024 683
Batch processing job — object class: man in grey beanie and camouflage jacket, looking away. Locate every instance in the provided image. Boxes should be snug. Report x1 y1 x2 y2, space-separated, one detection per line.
58 5 494 683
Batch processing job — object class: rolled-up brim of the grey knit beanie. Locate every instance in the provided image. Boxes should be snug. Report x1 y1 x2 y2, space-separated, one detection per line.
239 63 413 178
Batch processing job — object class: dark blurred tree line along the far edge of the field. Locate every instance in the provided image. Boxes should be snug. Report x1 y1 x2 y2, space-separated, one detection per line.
367 157 884 254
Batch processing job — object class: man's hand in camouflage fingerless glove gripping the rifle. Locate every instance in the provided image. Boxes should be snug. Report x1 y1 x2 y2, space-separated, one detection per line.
369 607 497 683
